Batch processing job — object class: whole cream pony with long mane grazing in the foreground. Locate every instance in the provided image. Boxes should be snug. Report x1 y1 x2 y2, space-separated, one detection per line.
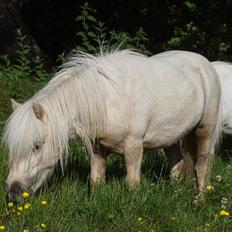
3 50 221 200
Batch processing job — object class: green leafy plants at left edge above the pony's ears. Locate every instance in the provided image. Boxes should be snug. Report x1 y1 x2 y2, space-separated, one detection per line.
0 29 48 101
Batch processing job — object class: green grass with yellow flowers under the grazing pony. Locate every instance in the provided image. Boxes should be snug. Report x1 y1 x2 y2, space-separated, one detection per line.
0 142 232 232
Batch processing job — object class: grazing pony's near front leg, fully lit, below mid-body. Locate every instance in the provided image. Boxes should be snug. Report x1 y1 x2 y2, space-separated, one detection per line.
124 137 143 188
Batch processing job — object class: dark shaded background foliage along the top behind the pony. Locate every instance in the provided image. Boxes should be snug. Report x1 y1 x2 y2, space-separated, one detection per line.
0 0 232 60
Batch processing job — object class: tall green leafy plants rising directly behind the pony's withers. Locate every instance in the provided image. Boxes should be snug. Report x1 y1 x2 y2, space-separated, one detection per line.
75 2 151 54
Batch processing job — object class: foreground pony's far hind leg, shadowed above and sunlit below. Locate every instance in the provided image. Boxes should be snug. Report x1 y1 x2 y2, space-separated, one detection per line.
164 142 183 180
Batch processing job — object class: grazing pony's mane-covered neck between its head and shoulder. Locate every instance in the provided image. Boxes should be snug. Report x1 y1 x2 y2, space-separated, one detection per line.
37 67 106 145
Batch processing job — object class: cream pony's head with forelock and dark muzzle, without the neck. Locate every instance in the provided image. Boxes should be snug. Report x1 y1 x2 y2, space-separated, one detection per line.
3 101 57 201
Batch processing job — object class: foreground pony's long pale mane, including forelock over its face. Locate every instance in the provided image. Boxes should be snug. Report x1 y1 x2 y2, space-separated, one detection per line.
3 50 145 165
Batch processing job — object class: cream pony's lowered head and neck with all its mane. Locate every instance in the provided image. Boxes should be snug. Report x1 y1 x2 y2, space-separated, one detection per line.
3 49 112 200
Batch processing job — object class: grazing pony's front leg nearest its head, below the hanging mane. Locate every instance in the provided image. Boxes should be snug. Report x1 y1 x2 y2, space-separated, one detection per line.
90 151 106 186
